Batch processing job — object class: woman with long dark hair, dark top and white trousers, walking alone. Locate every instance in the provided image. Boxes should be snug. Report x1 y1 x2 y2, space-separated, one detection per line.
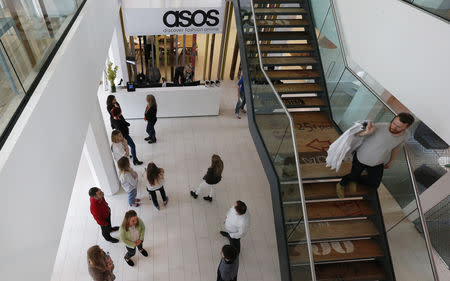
191 154 223 202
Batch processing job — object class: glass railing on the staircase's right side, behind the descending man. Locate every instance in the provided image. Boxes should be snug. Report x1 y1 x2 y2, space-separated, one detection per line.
311 0 438 281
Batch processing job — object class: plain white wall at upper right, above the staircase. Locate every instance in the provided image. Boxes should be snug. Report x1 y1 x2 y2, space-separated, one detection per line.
336 0 450 143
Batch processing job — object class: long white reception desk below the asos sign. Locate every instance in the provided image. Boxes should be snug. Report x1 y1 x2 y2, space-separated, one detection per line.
101 86 222 119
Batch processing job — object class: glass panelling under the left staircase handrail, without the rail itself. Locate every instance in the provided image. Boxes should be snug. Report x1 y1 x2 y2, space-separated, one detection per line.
239 1 312 281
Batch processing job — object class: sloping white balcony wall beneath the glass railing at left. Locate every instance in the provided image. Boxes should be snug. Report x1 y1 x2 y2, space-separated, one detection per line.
0 0 118 281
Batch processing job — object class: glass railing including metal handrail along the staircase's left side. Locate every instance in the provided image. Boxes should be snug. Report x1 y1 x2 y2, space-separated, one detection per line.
235 0 316 281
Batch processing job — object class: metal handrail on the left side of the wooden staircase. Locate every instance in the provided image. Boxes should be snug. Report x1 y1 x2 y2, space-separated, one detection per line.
250 0 317 281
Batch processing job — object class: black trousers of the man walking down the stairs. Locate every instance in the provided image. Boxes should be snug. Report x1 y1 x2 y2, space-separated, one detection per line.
340 152 384 188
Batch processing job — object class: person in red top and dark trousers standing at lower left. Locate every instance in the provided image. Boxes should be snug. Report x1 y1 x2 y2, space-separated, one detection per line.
89 187 119 243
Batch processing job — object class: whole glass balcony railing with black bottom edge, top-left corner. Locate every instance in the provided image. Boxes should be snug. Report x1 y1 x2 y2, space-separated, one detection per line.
0 0 86 147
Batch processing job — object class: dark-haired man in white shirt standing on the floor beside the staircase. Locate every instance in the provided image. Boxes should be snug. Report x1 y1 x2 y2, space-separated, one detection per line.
220 200 250 254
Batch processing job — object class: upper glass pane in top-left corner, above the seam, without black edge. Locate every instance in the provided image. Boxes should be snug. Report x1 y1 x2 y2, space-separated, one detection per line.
0 0 80 90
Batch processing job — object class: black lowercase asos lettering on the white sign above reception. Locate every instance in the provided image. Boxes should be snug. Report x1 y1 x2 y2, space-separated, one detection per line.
163 10 219 27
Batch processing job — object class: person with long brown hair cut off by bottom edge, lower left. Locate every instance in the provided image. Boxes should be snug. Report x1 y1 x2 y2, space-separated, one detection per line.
87 245 116 281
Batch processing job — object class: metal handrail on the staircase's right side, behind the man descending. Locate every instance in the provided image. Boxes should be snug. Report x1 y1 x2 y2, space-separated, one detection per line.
330 0 439 281
